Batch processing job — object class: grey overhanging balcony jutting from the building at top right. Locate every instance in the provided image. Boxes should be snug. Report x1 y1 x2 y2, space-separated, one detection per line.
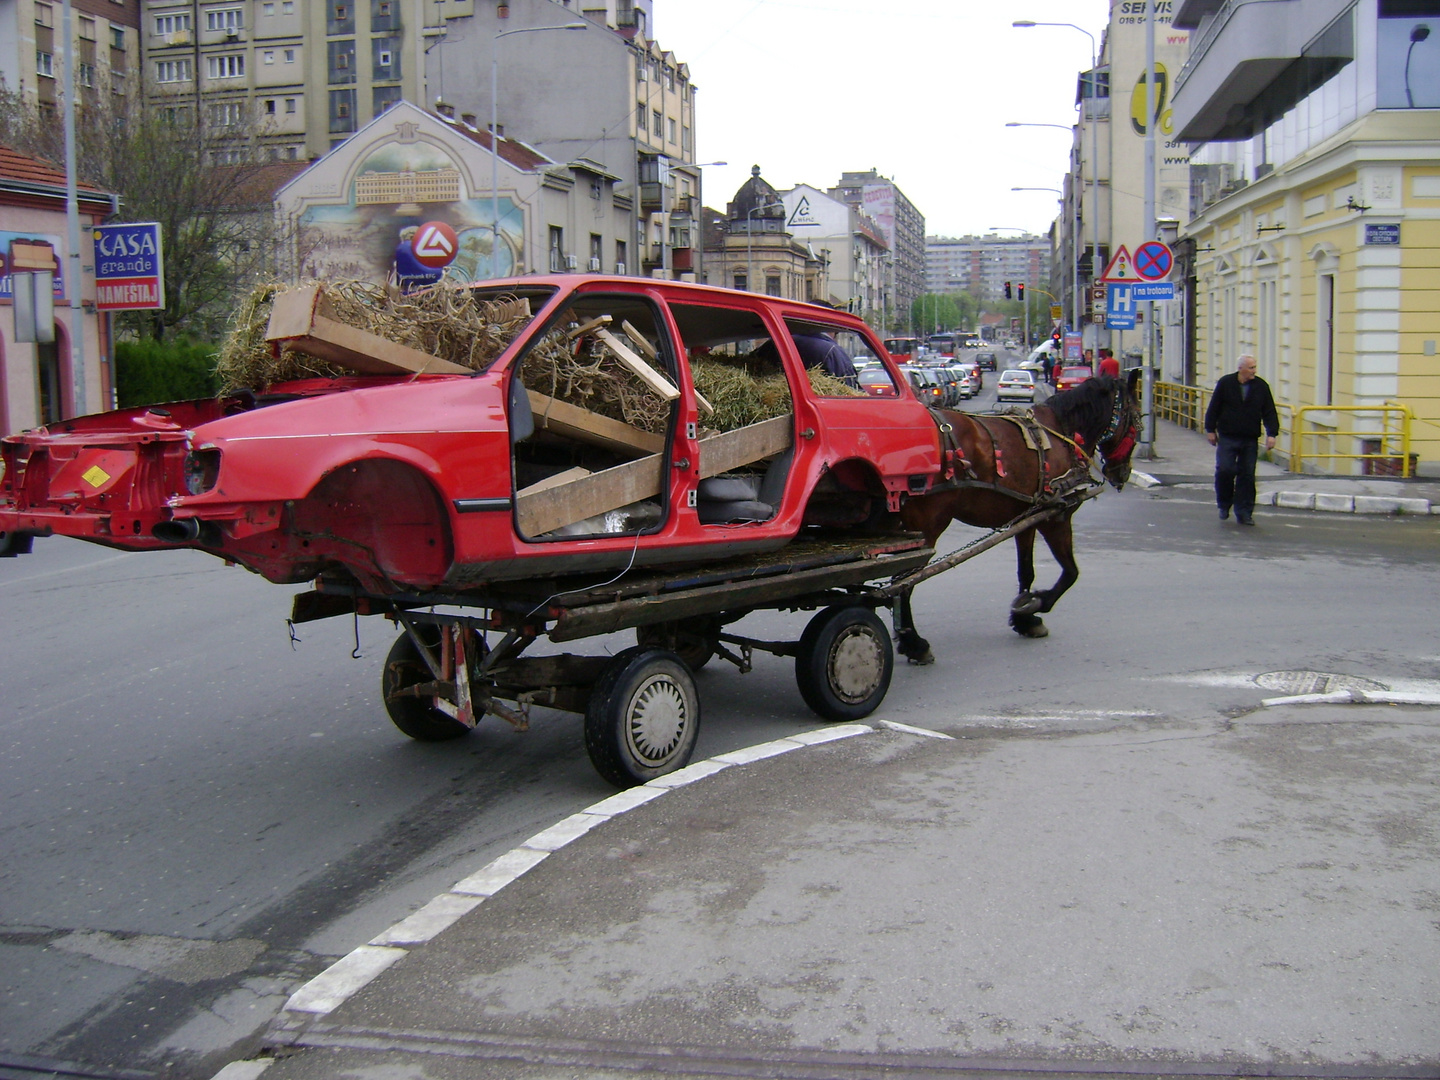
1174 0 1355 143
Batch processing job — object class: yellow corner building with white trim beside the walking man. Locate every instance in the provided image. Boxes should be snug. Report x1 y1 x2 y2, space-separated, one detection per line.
1165 0 1440 474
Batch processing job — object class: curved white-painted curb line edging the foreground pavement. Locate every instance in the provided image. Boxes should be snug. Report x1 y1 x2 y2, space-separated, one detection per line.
270 721 875 1025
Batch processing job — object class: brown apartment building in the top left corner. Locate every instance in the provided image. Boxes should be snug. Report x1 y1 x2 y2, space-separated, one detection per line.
0 0 140 111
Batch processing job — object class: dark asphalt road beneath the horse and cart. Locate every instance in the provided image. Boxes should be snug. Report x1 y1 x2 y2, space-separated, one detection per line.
0 443 1440 1077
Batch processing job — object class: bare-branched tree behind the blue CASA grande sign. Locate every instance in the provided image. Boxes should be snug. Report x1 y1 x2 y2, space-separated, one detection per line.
0 88 298 340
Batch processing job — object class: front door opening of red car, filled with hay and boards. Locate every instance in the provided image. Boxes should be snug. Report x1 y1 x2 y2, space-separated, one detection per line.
511 294 680 540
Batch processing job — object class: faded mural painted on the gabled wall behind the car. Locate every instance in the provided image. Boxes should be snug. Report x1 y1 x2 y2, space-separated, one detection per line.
301 141 524 282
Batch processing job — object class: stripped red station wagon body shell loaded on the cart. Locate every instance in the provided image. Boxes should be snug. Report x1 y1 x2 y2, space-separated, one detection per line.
0 275 940 595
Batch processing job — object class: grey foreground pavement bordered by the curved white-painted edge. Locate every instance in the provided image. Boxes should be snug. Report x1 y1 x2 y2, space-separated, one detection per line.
216 720 1440 1080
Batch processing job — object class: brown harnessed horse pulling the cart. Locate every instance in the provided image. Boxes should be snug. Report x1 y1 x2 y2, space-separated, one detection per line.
894 372 1140 664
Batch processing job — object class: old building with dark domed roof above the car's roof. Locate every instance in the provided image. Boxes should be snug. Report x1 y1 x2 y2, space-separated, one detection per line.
703 166 828 301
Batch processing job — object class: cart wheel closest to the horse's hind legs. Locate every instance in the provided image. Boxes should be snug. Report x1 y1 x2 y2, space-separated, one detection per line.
795 605 894 720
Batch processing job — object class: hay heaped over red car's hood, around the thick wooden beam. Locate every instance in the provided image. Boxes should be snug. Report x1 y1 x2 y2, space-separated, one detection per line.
215 281 541 395
